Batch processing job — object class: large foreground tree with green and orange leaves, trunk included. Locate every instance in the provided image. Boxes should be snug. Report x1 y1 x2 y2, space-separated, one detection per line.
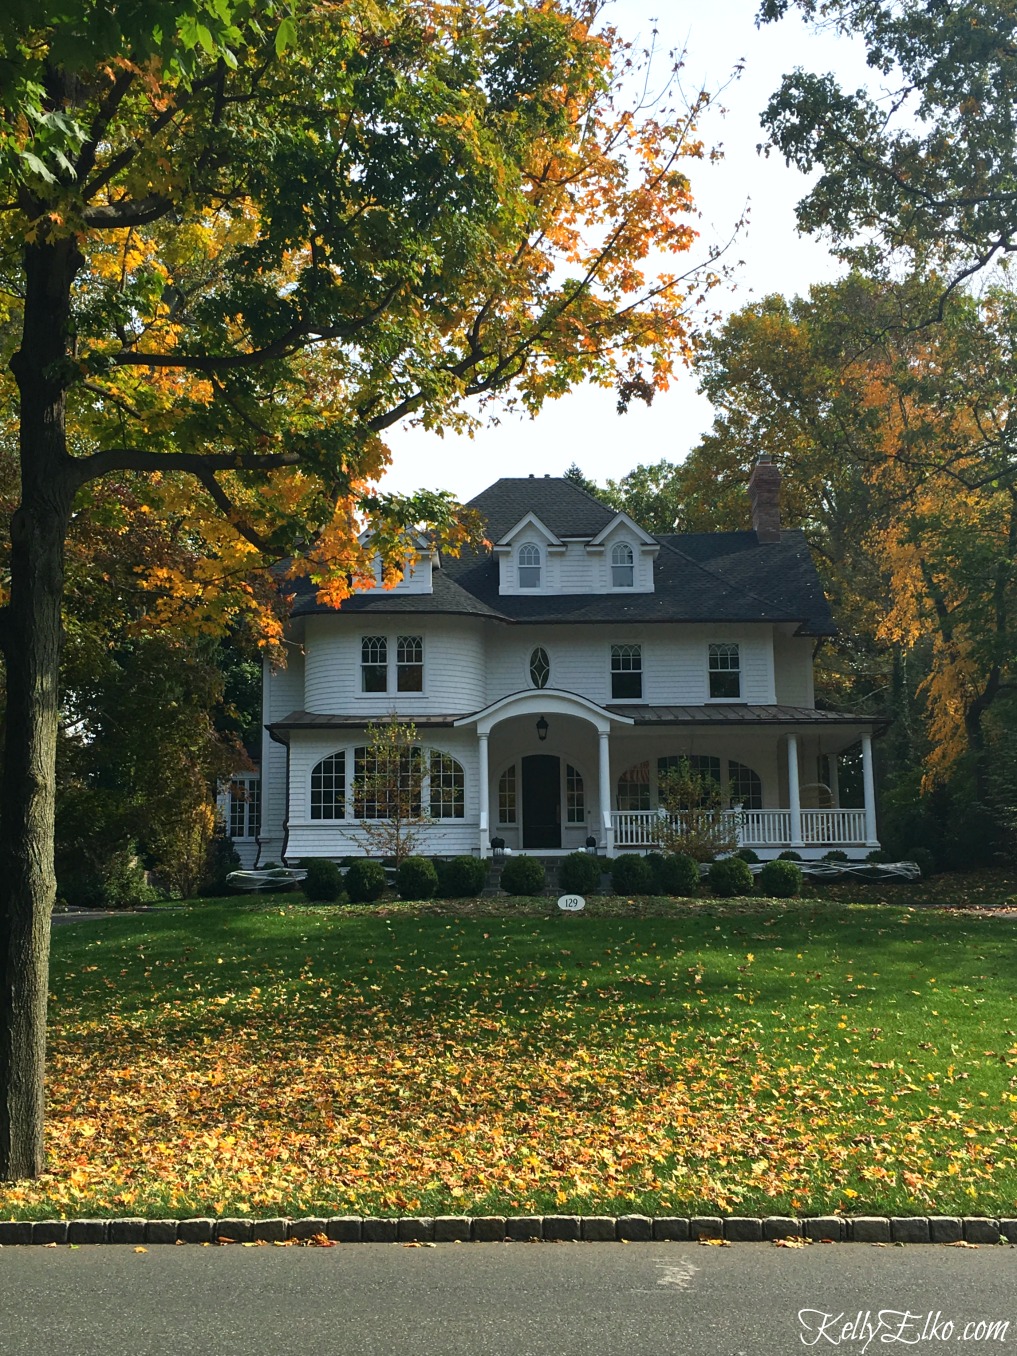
0 0 726 1178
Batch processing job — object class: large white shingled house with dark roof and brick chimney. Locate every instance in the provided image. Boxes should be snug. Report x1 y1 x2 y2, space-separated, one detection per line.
233 457 879 864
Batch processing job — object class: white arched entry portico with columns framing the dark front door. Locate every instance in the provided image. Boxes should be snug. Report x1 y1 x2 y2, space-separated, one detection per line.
456 687 632 854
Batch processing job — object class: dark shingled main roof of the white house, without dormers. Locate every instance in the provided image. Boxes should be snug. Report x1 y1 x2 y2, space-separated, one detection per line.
284 476 837 636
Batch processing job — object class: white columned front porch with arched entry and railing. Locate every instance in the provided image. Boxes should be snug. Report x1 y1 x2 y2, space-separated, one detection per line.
457 690 879 860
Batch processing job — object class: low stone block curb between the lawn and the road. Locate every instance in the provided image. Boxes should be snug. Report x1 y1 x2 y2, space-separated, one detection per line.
0 1215 1017 1248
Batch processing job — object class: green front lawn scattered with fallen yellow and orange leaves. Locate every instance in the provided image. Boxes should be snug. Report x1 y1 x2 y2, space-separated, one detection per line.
0 887 1017 1218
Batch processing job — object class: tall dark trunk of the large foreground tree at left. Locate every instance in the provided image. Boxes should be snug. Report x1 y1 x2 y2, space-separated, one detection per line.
0 240 81 1181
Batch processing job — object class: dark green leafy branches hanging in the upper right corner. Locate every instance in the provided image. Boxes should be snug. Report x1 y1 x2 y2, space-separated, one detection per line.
759 0 1017 282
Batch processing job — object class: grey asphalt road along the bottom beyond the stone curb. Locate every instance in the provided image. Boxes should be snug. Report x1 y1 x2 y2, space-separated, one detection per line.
0 1243 1017 1356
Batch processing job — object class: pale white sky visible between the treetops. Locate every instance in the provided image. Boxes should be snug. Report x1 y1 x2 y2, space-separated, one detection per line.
382 0 872 500
